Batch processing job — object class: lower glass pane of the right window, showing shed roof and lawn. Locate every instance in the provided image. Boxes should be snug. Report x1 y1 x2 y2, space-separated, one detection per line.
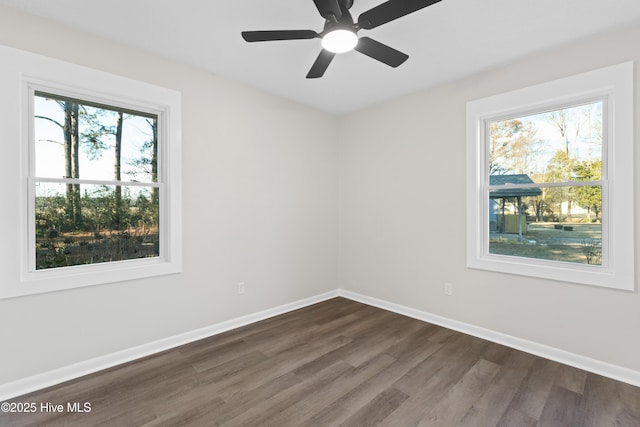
489 186 602 265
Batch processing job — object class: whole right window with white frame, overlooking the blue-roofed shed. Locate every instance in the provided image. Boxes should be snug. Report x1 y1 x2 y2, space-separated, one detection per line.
467 63 634 290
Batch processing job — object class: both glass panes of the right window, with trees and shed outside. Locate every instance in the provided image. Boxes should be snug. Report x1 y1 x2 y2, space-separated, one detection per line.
487 100 604 265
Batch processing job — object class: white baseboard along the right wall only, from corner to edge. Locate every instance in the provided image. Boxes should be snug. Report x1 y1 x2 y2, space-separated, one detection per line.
339 290 640 387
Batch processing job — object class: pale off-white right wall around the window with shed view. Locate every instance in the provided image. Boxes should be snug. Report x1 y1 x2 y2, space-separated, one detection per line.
340 27 640 370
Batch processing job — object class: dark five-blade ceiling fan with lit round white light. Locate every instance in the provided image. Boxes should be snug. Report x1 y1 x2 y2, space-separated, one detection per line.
242 0 441 79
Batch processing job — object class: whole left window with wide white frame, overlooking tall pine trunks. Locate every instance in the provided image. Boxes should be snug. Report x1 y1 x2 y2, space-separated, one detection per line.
0 48 182 298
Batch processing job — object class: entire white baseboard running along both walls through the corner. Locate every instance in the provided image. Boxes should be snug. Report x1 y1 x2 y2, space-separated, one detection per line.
0 289 640 402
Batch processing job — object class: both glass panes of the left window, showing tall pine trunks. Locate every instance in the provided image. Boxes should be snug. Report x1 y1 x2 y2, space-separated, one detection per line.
29 91 160 270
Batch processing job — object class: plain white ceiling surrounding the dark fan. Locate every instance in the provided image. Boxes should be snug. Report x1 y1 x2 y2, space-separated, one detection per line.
0 0 640 114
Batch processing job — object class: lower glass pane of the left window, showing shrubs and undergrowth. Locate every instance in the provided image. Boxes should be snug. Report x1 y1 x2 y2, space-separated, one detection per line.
35 183 160 270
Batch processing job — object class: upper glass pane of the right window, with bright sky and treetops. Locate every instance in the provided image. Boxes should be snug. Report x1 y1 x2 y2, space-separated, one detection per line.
488 100 604 183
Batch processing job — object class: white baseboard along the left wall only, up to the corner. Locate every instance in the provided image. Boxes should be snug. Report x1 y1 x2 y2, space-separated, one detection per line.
0 290 339 402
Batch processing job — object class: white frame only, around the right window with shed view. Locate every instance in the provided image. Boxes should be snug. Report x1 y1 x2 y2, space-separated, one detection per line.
467 62 635 291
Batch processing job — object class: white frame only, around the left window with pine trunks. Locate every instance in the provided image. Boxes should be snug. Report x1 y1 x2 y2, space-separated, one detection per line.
0 46 182 298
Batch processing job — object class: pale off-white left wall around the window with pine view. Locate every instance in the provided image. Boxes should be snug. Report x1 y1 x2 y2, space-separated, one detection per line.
0 7 338 384
